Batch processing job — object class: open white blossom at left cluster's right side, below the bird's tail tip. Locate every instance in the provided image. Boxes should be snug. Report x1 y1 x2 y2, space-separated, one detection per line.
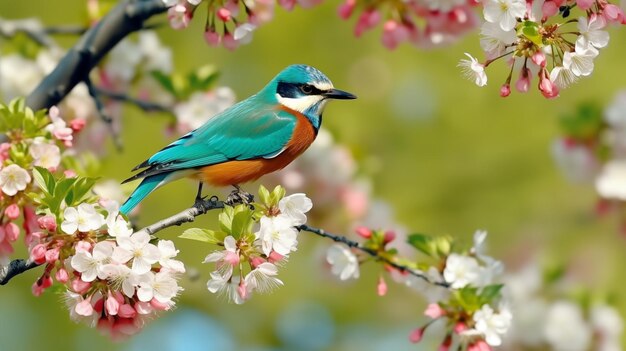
113 231 161 275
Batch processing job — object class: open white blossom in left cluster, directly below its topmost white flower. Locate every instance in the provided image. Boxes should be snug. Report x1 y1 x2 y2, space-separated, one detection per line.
71 241 114 282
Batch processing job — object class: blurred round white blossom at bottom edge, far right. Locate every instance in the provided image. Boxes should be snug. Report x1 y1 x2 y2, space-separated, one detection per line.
544 301 592 351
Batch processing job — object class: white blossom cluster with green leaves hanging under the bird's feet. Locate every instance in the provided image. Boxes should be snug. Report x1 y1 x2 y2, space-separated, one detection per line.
181 186 313 304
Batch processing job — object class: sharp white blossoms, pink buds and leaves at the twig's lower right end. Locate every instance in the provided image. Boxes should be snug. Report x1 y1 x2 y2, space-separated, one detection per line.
326 227 512 351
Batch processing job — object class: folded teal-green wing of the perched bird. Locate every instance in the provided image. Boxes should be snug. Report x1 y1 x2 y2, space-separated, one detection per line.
124 103 297 182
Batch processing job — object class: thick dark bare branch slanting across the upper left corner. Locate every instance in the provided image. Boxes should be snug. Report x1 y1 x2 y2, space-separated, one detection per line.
26 0 167 110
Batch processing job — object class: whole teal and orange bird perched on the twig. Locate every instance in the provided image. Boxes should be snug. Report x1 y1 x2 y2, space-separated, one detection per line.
120 65 356 214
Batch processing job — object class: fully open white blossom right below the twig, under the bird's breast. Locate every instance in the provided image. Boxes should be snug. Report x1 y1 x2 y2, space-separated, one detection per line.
255 214 298 256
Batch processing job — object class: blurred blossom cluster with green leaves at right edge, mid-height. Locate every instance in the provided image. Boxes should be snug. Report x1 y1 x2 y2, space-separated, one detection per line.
552 91 626 228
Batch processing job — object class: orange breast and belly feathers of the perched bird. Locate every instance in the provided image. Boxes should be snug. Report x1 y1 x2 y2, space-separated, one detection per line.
200 106 315 186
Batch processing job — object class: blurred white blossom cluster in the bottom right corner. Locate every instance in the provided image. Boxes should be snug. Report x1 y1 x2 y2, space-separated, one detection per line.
504 262 624 351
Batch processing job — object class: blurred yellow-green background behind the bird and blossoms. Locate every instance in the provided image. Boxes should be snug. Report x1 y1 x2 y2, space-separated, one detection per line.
0 0 626 350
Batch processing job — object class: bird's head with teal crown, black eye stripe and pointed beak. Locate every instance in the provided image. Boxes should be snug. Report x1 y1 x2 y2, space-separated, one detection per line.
267 65 356 128
